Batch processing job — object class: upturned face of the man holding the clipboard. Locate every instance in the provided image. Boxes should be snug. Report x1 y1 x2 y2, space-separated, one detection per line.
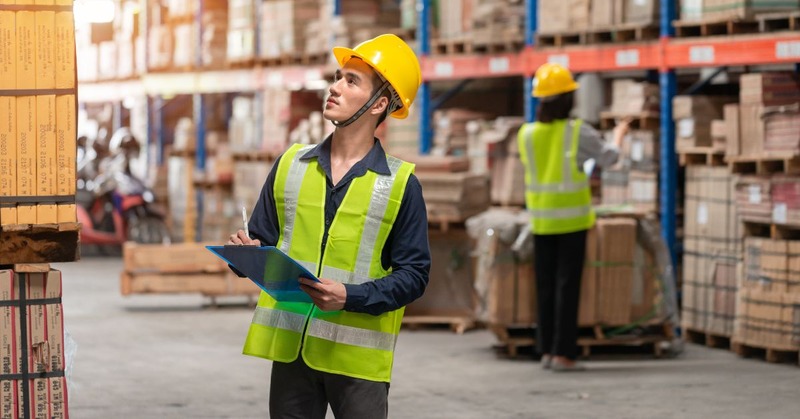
322 58 375 121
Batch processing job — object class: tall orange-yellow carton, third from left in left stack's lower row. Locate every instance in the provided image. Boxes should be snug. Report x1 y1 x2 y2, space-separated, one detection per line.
36 96 58 224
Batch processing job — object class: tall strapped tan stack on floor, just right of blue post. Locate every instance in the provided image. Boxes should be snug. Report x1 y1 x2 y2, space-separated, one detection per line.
681 166 743 338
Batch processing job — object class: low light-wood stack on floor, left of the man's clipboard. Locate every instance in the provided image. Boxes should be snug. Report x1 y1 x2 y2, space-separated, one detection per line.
120 241 259 298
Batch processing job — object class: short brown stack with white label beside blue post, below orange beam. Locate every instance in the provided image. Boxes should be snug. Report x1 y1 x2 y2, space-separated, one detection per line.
672 96 737 154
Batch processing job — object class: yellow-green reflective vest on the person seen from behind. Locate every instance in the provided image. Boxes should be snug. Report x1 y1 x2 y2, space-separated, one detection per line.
517 119 595 234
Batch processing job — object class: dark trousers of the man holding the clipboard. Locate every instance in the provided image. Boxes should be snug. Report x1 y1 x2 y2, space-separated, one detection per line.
269 356 389 419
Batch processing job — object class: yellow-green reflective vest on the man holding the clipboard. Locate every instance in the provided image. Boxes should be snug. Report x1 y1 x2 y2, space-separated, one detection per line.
243 145 414 382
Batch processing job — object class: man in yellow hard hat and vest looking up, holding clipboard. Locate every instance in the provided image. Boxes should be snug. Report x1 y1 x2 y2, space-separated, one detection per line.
229 35 431 419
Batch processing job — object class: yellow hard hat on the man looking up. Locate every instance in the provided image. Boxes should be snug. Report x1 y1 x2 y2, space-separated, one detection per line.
333 34 422 119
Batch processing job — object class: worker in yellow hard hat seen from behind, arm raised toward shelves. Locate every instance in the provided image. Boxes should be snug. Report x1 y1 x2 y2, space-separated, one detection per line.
517 63 628 372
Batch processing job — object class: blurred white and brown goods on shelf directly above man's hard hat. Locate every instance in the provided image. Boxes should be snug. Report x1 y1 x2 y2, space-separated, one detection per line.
305 0 402 55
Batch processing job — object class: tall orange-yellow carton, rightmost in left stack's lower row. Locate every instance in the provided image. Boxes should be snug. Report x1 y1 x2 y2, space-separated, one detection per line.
56 95 78 223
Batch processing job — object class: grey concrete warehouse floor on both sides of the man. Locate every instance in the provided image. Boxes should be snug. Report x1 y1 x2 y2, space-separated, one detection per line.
56 258 800 419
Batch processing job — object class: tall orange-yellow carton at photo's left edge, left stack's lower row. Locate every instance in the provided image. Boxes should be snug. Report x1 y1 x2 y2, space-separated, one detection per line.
0 96 17 225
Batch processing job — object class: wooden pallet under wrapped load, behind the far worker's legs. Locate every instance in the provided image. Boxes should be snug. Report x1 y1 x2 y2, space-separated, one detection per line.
489 323 672 358
